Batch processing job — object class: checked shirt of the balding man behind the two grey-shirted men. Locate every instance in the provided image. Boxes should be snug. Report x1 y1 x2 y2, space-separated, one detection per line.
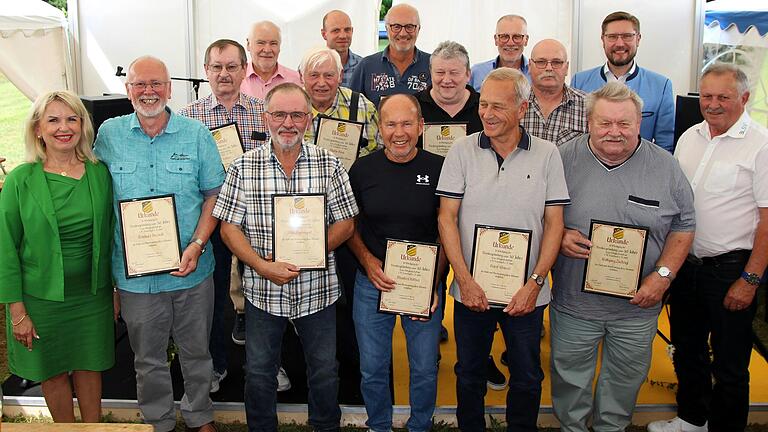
520 86 587 146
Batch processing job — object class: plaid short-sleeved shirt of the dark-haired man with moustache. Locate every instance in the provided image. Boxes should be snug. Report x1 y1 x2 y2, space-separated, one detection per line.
179 93 269 151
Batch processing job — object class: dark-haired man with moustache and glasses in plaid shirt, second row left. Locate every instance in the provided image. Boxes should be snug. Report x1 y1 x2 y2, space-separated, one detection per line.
179 39 291 393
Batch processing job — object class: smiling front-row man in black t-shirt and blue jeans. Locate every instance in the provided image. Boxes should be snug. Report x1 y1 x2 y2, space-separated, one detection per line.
347 94 446 431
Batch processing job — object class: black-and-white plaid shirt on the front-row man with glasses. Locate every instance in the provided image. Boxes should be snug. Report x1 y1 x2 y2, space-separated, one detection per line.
213 143 358 318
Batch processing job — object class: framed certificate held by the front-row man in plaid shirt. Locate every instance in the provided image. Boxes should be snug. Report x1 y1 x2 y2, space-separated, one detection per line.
272 194 328 270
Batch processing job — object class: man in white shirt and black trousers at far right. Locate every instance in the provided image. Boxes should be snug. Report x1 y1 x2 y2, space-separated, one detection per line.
648 63 768 432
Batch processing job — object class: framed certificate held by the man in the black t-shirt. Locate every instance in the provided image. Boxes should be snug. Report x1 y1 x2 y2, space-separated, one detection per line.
379 239 440 318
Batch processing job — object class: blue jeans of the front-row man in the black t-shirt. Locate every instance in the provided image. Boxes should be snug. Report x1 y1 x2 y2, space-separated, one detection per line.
352 272 442 432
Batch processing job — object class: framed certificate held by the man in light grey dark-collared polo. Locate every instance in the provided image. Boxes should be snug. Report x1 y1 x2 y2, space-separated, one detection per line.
470 225 532 306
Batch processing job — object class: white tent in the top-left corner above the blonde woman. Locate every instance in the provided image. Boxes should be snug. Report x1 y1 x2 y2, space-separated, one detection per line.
0 0 72 100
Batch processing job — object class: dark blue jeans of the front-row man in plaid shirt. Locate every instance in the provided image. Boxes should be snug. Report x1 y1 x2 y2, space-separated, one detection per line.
245 301 341 432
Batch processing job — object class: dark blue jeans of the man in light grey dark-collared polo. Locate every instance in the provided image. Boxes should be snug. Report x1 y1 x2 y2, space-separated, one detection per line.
453 302 546 432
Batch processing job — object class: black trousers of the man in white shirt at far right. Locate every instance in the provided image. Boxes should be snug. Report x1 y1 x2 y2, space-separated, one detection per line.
670 255 757 432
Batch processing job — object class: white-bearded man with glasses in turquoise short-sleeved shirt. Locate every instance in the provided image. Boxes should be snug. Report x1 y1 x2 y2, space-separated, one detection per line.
94 56 224 432
